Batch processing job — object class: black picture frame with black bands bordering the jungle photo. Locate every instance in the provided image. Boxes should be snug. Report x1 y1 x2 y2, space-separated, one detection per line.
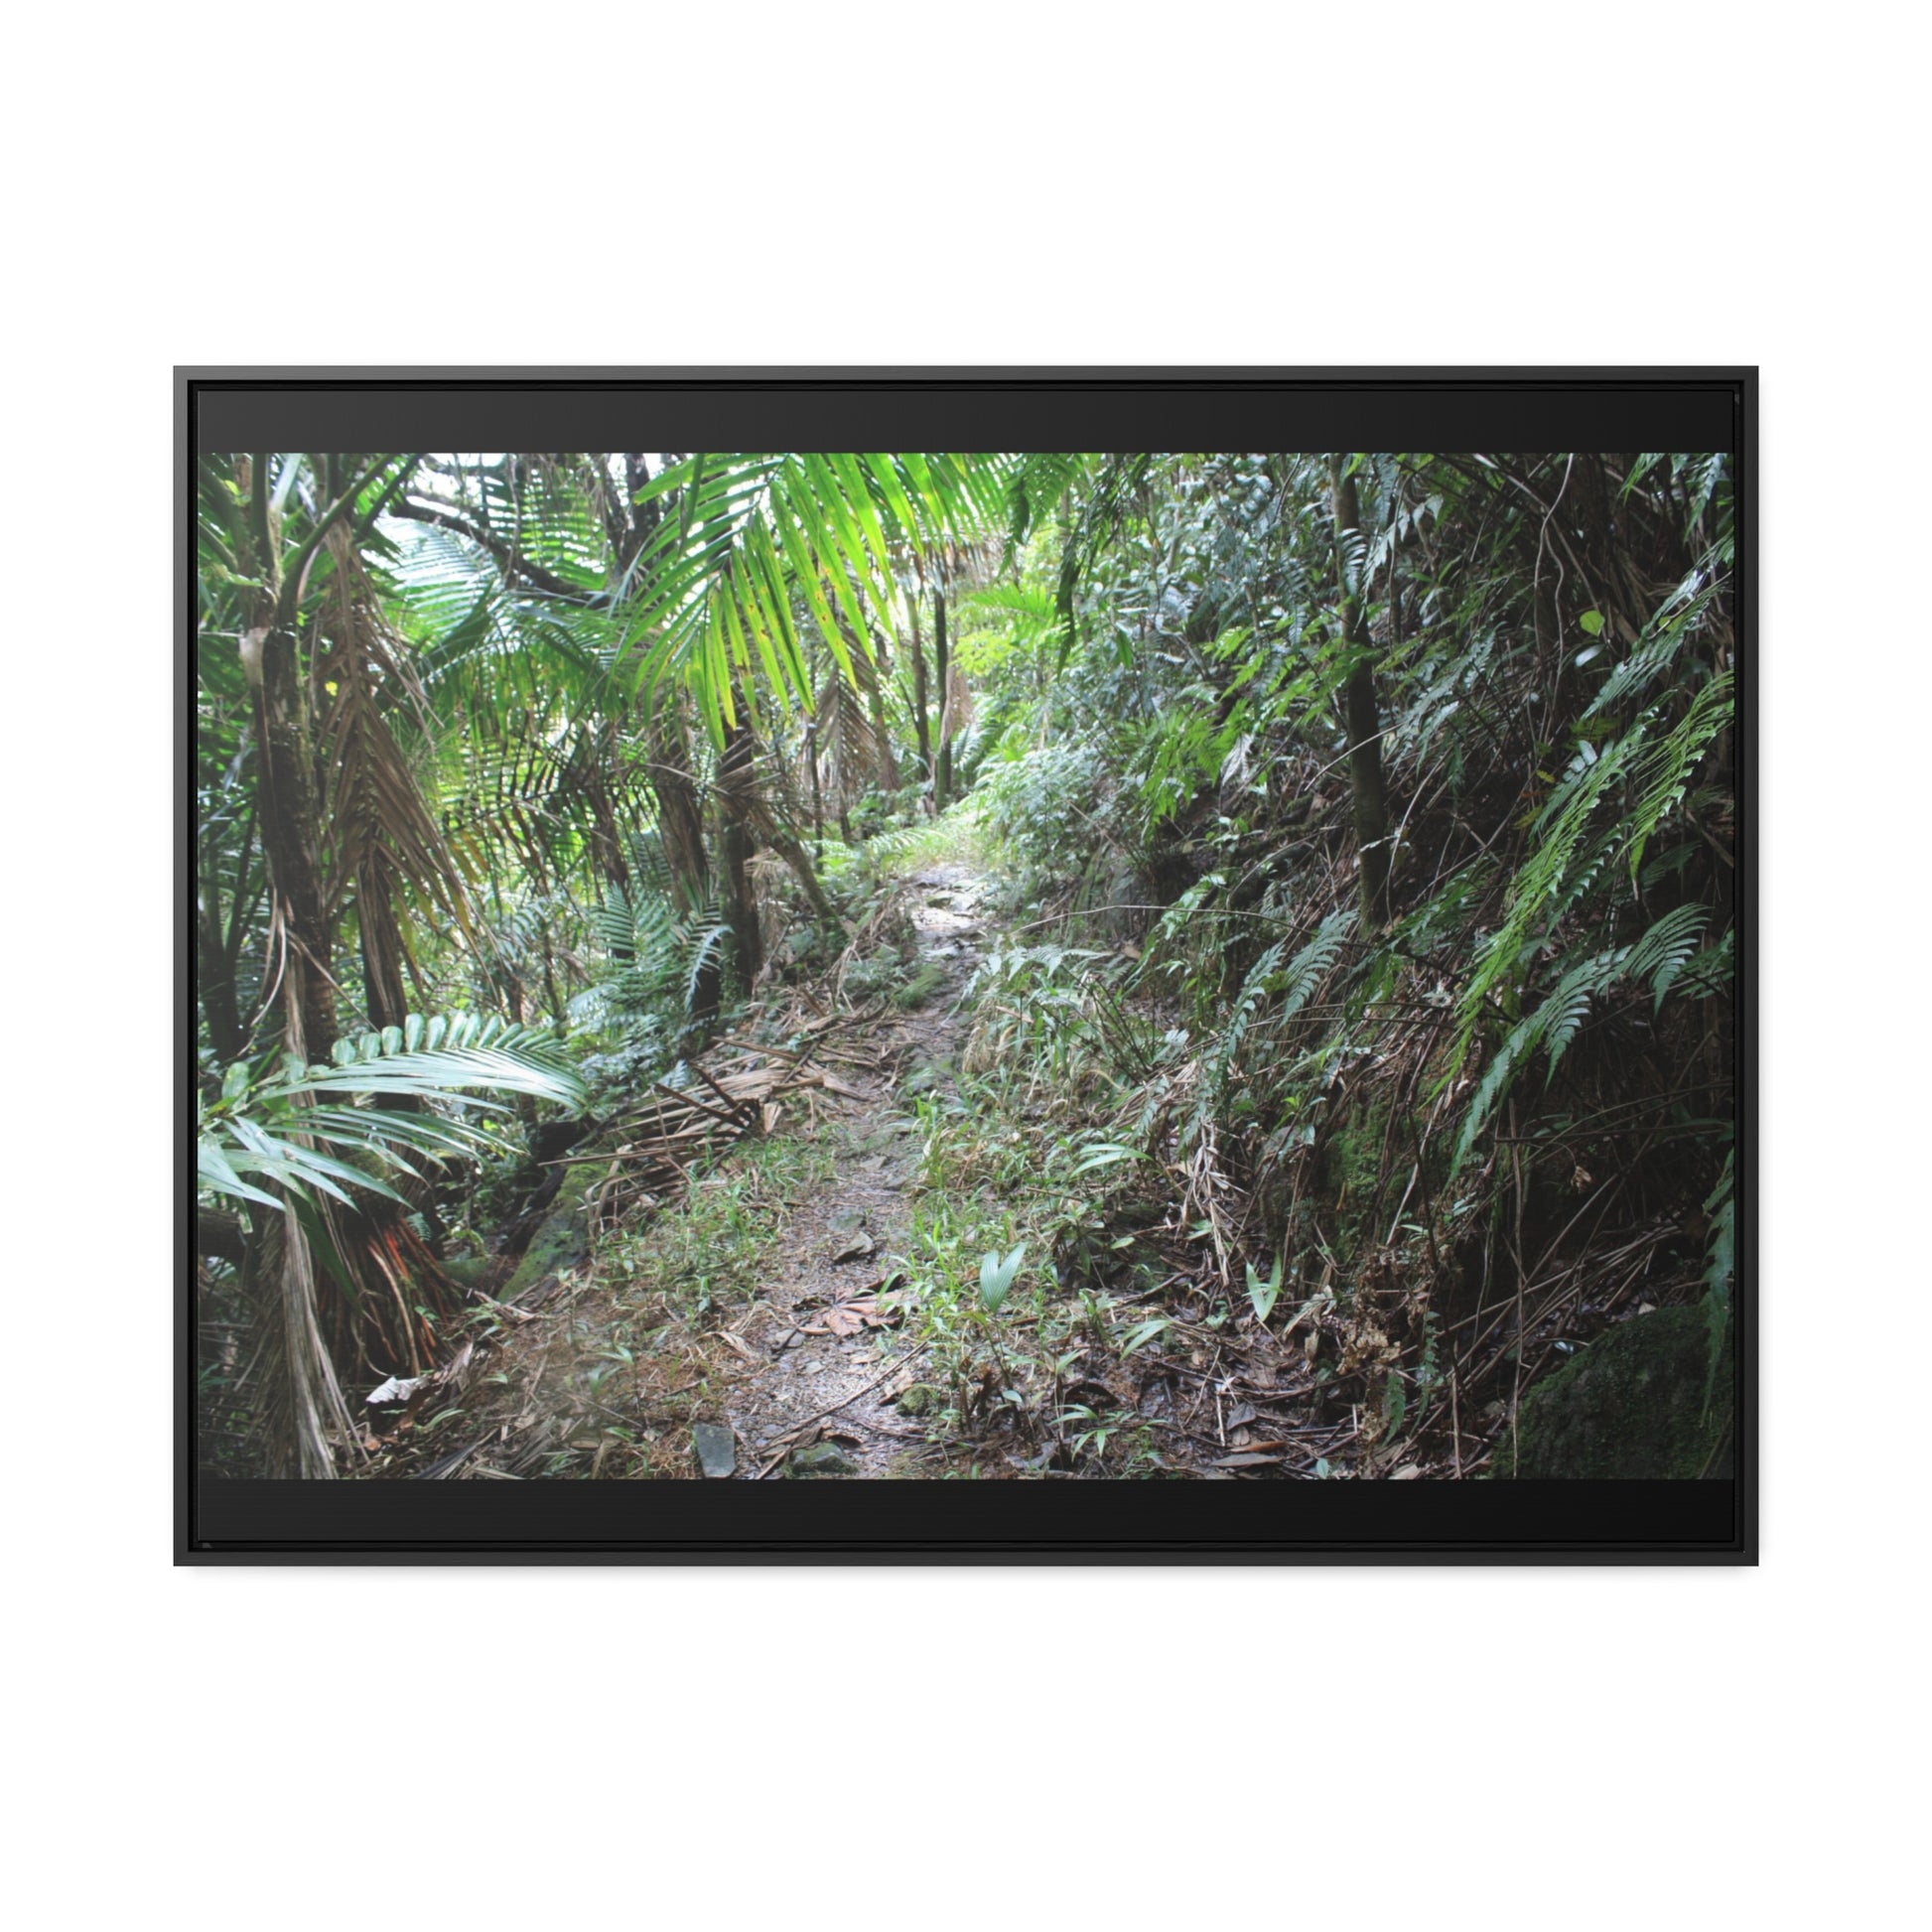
174 367 1758 1565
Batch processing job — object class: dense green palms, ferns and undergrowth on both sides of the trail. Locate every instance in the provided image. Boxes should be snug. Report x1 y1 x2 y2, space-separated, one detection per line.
194 452 1735 1476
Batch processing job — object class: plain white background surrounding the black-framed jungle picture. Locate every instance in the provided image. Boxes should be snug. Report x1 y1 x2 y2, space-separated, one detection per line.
11 0 1926 1932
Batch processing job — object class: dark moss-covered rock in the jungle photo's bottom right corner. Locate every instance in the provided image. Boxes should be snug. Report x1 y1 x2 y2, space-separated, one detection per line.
1495 1308 1731 1478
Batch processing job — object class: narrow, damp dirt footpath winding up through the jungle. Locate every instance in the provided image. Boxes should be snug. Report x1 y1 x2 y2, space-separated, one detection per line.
725 864 987 1480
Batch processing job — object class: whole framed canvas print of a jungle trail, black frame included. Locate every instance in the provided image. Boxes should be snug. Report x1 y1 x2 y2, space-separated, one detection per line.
176 369 1756 1563
